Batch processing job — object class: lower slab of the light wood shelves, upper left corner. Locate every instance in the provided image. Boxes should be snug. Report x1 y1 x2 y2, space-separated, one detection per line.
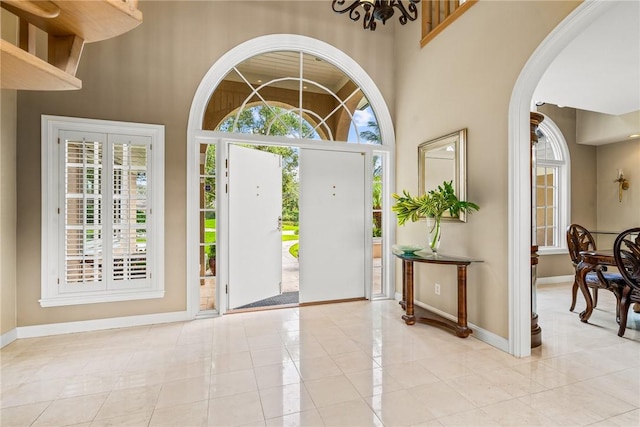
0 40 82 90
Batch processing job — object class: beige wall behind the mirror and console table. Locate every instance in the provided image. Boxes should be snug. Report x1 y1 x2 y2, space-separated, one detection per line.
396 1 579 337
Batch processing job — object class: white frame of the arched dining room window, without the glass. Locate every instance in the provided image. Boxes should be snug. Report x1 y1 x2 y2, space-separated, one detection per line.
536 116 571 255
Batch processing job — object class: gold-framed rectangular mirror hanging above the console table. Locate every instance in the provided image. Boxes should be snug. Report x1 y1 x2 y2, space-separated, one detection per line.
418 128 467 222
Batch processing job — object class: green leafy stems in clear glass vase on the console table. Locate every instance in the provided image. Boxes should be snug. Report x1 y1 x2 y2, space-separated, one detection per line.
392 181 480 253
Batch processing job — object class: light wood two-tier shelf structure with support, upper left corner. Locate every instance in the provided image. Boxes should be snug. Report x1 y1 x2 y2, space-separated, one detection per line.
0 0 142 90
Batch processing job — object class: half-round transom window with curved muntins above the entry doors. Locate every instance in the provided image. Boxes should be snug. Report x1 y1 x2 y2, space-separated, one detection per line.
202 51 381 144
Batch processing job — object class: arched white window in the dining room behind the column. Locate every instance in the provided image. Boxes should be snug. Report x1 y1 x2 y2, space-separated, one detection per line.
535 116 571 255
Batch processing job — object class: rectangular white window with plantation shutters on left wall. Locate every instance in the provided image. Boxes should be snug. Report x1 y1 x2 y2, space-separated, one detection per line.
40 115 164 306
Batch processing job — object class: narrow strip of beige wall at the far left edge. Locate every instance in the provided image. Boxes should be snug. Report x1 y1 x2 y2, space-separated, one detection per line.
0 9 17 335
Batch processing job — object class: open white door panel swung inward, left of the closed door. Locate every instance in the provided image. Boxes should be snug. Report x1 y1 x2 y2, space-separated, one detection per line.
228 144 282 309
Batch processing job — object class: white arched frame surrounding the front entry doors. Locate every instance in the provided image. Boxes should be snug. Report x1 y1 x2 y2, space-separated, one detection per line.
186 34 395 319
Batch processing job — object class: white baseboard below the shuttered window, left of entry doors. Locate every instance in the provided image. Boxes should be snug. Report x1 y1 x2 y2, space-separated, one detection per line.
14 311 191 339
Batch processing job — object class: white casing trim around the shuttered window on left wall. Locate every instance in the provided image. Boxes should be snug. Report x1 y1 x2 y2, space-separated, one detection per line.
39 115 164 307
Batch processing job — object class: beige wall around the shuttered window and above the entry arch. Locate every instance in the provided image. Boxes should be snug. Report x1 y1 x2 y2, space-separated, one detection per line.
17 0 396 326
